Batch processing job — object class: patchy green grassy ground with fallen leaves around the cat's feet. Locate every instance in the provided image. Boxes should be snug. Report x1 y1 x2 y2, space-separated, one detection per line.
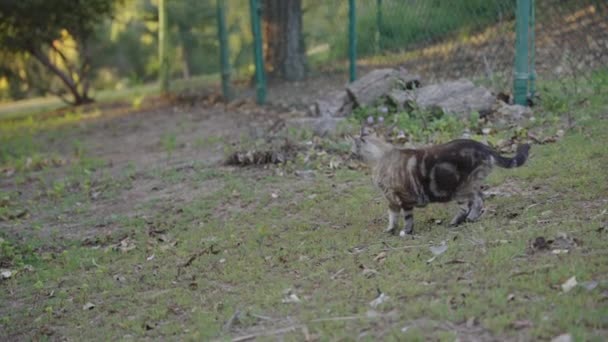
0 73 608 341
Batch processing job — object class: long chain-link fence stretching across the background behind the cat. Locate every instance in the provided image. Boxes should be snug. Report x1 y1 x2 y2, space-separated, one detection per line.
0 0 608 104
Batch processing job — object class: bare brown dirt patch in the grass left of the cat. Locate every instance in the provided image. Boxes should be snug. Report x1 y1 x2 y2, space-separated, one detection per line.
0 101 306 244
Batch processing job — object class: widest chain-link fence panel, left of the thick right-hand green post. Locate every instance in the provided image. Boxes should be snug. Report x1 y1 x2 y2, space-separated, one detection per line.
358 0 515 88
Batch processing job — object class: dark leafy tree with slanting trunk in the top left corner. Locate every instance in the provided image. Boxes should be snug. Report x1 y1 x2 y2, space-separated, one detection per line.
0 0 120 105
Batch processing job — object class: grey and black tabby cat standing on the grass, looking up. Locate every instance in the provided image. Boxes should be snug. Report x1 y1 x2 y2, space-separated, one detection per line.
352 129 530 235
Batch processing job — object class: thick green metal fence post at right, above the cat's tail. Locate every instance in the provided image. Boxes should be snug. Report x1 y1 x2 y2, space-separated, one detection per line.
513 0 530 105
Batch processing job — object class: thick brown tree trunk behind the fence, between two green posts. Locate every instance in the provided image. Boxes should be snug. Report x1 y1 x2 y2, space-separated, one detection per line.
263 0 307 81
